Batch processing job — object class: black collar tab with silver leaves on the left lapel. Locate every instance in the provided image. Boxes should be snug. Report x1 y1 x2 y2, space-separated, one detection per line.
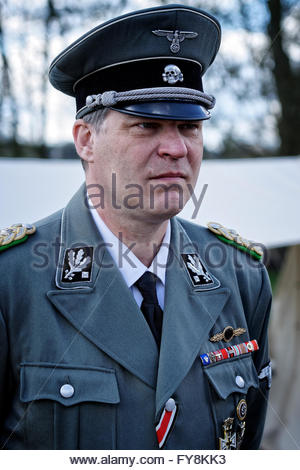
61 246 94 282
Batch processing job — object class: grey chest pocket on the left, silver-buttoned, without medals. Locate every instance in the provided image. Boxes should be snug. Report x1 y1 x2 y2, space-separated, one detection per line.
20 363 120 449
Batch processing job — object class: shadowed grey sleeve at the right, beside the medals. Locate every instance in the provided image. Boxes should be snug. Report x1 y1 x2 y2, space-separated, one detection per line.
241 267 272 449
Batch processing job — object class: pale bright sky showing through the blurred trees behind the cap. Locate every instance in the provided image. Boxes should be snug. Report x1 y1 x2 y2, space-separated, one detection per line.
1 0 300 151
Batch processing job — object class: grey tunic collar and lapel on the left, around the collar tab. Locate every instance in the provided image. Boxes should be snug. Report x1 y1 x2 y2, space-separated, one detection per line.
47 186 158 388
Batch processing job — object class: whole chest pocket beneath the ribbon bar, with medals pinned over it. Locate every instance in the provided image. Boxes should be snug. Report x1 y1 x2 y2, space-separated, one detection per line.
204 354 259 449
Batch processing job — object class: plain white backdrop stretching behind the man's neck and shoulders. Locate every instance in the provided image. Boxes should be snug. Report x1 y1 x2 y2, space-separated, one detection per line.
0 157 300 248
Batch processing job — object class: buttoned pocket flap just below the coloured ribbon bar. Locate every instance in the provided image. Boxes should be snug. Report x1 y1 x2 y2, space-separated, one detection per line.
203 355 258 400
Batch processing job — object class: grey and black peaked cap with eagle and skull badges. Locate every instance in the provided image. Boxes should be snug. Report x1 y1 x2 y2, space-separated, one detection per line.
49 5 221 119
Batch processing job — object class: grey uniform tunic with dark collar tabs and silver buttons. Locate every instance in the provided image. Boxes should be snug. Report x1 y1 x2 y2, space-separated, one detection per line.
0 187 271 449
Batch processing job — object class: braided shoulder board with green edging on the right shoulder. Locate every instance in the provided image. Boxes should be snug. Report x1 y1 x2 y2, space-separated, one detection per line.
207 222 264 260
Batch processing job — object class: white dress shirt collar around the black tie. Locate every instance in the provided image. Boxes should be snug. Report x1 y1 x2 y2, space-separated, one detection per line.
89 205 171 310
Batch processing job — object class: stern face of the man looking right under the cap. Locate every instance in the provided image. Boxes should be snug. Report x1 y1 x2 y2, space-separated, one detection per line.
87 111 203 221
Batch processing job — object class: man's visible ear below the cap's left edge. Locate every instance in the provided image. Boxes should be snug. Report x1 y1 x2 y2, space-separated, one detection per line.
73 119 94 163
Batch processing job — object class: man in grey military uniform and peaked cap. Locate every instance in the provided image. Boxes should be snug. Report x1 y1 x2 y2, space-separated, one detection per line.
0 5 270 449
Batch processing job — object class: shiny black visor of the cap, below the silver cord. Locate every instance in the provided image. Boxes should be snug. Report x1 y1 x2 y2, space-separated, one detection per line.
111 101 210 121
